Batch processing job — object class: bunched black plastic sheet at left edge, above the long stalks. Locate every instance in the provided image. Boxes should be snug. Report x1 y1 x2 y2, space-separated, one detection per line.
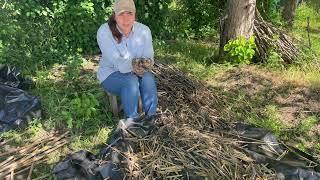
0 65 41 134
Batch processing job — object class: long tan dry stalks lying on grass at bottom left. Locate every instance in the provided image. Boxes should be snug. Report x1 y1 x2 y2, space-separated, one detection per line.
0 132 69 179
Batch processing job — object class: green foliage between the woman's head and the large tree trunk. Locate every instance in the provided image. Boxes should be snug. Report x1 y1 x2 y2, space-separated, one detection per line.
136 0 225 40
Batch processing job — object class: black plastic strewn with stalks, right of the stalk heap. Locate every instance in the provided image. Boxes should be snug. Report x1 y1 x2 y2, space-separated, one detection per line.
235 123 320 180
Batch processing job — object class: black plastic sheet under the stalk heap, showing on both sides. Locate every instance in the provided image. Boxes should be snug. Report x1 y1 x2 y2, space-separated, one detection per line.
53 119 320 180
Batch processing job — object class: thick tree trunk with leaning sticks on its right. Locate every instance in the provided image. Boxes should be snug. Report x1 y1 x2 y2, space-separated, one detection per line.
219 0 256 56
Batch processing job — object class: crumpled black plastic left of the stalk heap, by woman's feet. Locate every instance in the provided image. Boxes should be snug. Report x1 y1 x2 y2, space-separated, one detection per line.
53 116 156 180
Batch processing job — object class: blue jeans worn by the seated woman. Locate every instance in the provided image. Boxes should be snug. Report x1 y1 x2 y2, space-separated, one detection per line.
101 71 158 118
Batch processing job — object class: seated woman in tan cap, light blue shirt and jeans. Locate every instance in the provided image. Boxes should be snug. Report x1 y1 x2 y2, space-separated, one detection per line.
97 0 158 119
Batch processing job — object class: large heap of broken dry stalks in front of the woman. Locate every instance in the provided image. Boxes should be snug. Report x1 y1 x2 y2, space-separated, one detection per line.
119 64 275 179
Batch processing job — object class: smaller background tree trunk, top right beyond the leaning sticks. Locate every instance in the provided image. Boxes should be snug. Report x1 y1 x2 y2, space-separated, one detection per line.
282 0 299 27
